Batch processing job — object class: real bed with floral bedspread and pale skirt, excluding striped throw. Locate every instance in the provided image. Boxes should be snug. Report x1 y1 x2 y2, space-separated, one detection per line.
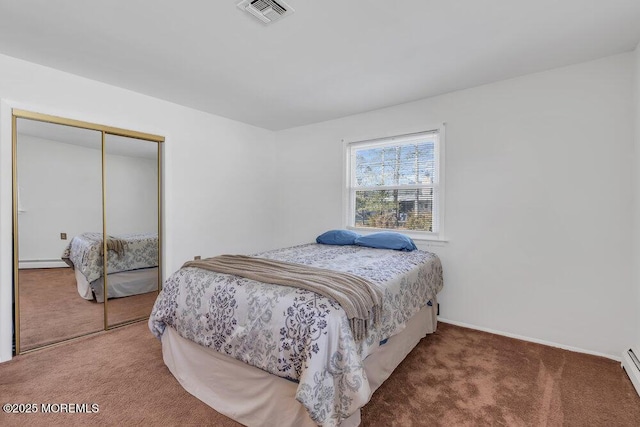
149 243 443 426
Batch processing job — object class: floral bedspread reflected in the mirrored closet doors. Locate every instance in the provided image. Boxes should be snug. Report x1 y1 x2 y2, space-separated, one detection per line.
62 233 158 283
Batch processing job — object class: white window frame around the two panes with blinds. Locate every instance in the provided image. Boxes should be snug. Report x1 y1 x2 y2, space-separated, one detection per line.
342 123 446 242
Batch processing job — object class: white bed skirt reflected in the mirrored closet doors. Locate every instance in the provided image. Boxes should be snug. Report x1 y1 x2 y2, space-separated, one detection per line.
75 267 158 303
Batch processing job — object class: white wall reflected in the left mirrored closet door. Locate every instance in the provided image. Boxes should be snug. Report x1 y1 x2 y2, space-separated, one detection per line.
18 132 102 268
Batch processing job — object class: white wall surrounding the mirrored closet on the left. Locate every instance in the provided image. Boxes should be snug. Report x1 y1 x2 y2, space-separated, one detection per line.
0 55 276 361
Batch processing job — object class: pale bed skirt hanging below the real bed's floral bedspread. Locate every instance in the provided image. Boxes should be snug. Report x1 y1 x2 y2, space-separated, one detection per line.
162 298 437 427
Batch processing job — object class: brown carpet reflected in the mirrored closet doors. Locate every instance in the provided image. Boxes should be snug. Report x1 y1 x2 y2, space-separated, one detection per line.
19 268 157 351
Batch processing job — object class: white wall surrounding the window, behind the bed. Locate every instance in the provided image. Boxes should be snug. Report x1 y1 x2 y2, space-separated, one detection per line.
277 53 637 358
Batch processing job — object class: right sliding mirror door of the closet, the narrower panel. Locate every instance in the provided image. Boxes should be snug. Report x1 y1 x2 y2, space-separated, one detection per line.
104 133 160 327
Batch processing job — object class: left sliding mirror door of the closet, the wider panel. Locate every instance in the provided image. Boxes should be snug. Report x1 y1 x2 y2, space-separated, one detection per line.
14 117 104 352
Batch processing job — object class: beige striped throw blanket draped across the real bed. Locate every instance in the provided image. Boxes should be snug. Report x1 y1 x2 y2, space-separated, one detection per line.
182 255 382 341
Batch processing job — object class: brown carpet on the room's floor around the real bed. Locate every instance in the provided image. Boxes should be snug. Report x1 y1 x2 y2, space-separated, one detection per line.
0 323 640 427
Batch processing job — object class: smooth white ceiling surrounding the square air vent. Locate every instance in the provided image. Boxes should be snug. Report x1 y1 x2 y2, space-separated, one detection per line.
0 0 640 130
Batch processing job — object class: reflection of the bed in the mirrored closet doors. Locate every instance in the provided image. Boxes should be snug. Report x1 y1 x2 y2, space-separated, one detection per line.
62 233 158 303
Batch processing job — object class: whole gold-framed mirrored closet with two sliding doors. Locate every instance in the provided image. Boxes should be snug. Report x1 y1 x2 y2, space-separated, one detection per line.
13 110 164 354
